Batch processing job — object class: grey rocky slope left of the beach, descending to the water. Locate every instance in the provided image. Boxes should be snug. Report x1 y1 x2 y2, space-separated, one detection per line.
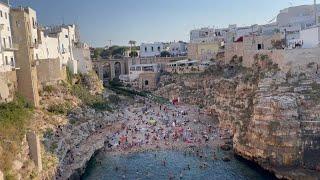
44 108 121 179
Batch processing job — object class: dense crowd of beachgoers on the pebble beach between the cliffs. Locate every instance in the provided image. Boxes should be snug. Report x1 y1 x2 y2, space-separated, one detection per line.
106 99 219 156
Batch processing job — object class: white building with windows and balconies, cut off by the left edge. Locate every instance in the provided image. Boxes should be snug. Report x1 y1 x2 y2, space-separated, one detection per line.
0 1 18 72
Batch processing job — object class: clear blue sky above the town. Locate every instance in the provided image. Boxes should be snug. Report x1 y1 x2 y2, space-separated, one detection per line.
10 0 313 47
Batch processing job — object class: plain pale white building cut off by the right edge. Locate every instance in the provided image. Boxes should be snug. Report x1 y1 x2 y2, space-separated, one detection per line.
300 26 320 48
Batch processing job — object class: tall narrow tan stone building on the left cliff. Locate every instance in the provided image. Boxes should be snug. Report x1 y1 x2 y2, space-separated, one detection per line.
10 7 39 107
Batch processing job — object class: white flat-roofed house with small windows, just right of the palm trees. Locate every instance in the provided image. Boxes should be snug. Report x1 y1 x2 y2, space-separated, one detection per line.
140 42 165 57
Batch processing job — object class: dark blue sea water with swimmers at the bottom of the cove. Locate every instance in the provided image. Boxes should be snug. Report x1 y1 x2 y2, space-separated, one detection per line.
82 149 273 180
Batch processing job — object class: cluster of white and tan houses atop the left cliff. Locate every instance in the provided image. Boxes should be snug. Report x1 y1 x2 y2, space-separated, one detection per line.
0 2 92 107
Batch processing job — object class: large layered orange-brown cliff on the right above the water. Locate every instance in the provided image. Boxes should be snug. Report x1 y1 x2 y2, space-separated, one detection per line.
156 63 320 179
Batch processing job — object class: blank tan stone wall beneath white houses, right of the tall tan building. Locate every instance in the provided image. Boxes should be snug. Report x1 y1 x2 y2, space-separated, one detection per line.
37 59 63 86
